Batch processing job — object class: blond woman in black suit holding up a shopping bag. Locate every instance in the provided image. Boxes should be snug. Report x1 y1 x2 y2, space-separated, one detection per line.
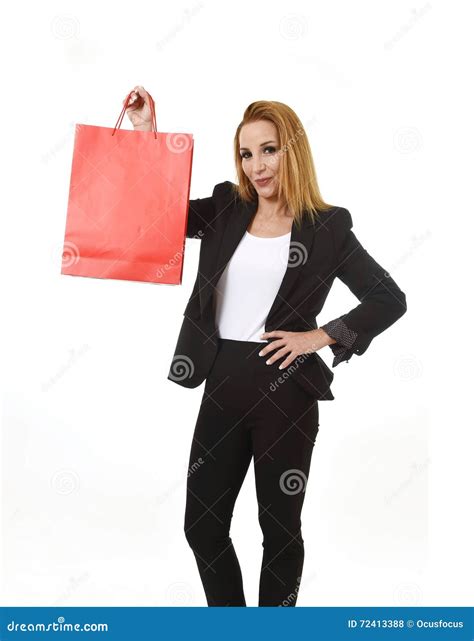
127 86 406 606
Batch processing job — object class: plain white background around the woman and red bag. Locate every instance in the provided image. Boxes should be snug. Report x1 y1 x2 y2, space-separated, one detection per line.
1 0 474 606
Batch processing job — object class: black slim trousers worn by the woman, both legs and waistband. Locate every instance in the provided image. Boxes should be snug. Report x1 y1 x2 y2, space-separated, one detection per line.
185 339 319 606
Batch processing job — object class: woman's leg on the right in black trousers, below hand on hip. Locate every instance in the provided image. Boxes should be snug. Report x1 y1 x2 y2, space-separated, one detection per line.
252 374 319 606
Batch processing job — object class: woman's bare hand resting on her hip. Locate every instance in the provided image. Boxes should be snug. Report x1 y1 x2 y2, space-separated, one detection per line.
259 329 328 369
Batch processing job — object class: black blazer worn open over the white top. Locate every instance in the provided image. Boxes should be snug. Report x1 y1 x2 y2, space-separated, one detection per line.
168 181 407 400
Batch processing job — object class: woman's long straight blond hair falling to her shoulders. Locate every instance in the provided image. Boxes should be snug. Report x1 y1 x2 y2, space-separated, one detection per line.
234 100 333 225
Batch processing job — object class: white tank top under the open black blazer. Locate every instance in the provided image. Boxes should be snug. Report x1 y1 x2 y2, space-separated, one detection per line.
214 231 291 343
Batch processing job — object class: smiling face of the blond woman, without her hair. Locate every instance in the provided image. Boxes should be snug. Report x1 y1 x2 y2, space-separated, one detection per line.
239 120 280 198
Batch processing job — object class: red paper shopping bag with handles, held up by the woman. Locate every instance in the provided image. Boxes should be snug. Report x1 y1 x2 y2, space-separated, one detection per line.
61 92 194 284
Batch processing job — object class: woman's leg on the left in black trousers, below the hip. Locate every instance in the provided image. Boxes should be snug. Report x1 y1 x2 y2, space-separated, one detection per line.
185 349 252 606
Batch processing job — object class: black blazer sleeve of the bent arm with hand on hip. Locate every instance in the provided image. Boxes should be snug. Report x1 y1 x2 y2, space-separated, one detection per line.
321 207 407 367
